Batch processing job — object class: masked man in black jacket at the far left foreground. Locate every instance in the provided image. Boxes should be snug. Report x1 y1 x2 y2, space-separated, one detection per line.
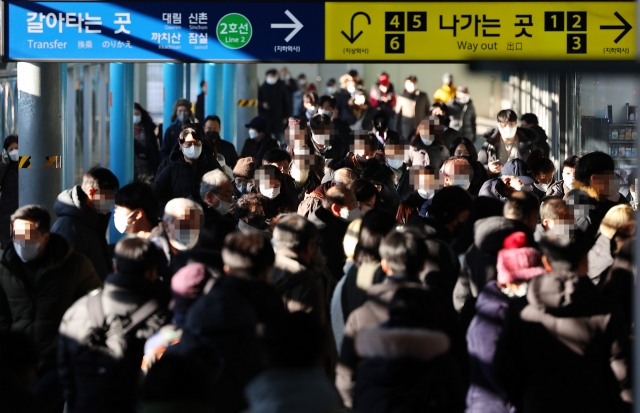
0 205 104 412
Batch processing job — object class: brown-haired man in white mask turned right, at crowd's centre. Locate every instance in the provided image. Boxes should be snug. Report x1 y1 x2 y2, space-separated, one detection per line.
309 186 361 281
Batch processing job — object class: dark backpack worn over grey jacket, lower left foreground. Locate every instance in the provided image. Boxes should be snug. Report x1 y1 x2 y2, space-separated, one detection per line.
72 290 159 411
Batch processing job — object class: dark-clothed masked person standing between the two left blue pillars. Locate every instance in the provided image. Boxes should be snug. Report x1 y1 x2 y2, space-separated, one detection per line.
133 103 160 178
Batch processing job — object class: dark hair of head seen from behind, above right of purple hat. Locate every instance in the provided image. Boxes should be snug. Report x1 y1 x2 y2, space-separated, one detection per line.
222 230 276 278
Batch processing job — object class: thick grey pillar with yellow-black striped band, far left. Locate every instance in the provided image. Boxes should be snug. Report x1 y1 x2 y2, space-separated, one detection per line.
18 62 67 219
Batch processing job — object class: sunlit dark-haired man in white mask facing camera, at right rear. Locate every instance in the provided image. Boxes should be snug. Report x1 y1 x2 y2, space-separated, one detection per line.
478 109 536 178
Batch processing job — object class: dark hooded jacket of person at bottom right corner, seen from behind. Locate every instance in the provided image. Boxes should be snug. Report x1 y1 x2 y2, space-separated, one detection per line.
494 273 631 413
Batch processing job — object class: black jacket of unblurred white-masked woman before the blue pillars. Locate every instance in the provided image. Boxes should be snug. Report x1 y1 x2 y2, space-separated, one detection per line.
153 143 220 206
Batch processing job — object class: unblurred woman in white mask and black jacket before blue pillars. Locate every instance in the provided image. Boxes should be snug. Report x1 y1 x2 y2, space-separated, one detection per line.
154 125 220 207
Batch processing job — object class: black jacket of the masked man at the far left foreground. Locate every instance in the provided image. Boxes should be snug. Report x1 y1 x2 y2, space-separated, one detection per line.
0 234 102 373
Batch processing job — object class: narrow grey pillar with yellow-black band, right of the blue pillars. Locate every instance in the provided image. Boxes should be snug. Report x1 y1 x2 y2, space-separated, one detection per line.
233 63 258 152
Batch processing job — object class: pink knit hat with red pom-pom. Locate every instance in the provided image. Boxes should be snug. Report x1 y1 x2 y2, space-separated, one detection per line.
497 232 546 285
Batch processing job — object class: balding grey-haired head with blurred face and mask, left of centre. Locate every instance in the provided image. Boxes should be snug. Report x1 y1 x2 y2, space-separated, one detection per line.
162 198 204 251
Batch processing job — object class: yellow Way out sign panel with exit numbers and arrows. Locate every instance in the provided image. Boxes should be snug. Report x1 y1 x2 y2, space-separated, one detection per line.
325 1 636 61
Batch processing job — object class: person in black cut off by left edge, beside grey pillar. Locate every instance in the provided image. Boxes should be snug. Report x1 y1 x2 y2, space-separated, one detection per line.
0 135 20 249
